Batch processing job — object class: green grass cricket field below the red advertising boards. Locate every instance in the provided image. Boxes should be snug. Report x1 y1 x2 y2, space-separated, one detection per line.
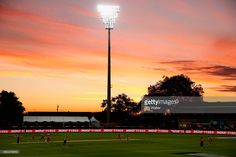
0 133 236 157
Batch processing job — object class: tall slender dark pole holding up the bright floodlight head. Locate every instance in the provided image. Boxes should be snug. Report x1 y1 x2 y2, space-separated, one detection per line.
107 28 111 123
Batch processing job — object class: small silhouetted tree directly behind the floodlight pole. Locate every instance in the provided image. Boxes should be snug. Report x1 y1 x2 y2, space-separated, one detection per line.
101 93 139 114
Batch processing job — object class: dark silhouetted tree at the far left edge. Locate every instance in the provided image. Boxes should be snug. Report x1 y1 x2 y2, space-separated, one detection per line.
0 90 25 126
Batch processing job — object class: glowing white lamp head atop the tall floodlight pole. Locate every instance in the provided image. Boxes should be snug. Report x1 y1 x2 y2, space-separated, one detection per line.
97 5 120 29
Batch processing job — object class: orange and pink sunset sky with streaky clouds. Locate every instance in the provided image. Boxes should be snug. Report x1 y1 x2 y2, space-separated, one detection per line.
0 0 236 112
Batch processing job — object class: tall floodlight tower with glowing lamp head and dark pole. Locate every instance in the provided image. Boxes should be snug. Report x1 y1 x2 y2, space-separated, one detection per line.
97 5 120 123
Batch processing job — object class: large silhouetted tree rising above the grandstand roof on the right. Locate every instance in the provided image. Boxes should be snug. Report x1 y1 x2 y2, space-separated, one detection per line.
147 74 204 96
